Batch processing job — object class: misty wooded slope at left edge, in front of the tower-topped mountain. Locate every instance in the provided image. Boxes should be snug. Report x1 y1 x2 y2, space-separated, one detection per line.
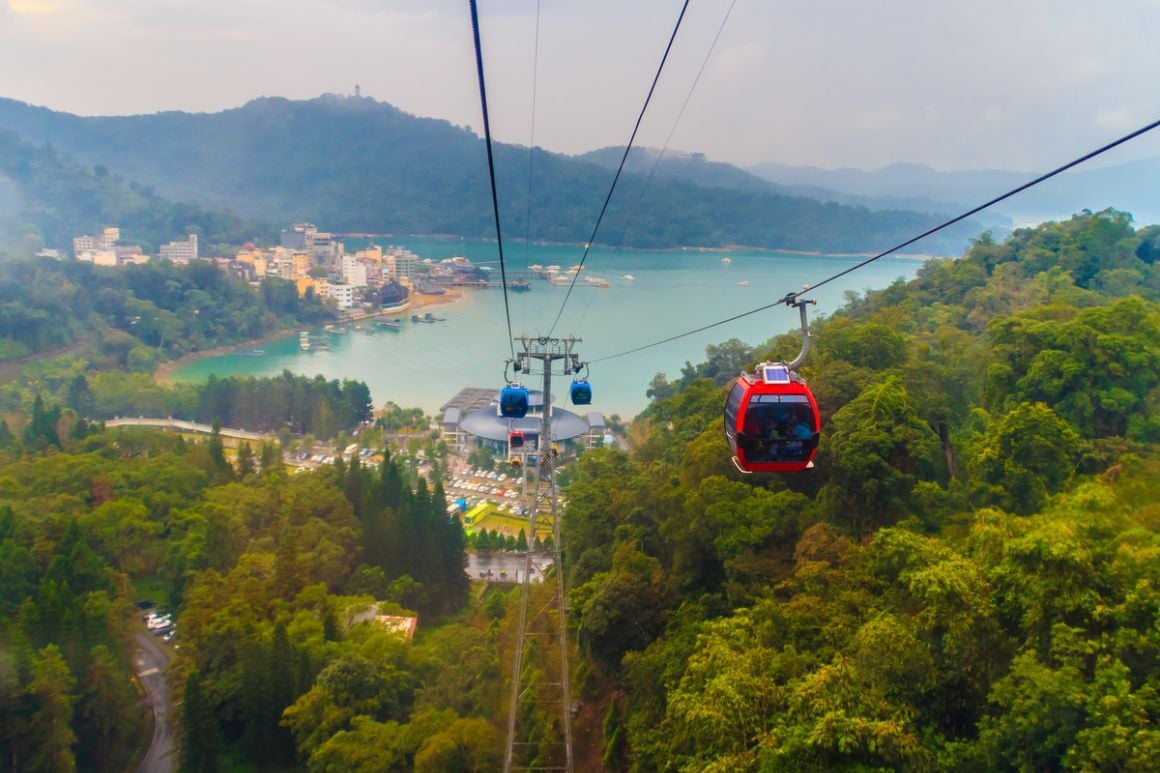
0 129 274 255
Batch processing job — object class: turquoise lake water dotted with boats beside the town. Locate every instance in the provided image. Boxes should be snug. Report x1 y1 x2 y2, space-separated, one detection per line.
174 237 921 418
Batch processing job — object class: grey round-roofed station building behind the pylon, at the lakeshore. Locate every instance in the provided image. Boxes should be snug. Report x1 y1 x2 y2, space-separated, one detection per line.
442 388 608 454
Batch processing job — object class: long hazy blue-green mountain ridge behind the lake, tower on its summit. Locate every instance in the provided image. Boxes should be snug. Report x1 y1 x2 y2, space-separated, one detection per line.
0 95 979 254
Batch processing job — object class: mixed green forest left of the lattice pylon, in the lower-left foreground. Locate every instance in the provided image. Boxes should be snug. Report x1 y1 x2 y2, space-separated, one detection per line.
0 432 480 773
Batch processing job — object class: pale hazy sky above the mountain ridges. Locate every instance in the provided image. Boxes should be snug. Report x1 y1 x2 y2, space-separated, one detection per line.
0 0 1160 171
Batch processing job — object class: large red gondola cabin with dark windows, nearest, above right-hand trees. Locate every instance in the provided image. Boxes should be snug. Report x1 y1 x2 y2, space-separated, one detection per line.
725 362 821 472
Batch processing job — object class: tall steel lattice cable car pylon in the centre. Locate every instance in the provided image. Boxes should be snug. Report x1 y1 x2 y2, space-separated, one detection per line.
503 335 581 773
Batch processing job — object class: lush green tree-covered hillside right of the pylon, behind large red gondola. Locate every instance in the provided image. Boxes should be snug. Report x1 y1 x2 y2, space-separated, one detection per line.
564 211 1160 771
